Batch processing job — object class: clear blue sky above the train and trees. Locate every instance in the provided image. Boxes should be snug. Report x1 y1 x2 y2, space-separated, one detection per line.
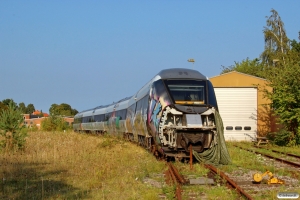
0 0 300 112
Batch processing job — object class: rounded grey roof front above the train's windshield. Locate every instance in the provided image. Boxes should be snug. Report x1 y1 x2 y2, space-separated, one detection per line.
157 68 207 80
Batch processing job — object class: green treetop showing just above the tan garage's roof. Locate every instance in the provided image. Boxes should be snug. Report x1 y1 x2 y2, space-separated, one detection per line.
221 58 264 78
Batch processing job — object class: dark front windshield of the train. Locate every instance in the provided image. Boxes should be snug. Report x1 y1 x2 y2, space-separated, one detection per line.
165 80 206 104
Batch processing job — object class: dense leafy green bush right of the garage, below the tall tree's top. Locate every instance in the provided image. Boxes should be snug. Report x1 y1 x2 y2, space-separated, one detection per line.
264 60 300 144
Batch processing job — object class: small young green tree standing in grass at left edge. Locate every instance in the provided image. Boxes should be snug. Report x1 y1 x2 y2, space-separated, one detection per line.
0 101 27 152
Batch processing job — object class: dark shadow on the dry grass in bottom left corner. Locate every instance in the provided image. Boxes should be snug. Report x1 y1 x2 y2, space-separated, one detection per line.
0 161 89 199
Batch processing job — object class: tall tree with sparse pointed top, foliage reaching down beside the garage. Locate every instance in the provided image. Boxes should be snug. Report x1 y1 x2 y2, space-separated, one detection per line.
261 9 300 144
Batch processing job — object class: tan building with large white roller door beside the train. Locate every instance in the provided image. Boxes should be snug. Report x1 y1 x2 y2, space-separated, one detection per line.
210 71 273 140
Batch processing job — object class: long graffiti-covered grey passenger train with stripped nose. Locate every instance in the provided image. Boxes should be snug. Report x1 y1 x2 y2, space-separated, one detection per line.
73 68 230 162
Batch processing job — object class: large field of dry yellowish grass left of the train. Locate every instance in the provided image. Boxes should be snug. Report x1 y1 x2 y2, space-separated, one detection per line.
0 132 165 199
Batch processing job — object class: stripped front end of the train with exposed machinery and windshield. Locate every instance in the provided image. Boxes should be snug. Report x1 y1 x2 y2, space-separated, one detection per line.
147 69 218 157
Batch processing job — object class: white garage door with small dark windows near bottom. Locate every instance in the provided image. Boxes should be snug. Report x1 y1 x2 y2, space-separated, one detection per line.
215 88 257 141
